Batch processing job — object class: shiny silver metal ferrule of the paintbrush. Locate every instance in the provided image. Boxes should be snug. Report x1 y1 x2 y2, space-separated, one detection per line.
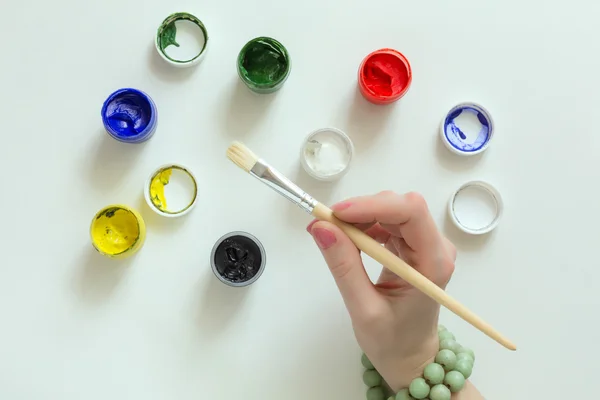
250 160 317 214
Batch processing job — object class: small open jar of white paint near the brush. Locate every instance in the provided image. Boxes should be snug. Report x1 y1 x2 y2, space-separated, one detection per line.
300 128 354 182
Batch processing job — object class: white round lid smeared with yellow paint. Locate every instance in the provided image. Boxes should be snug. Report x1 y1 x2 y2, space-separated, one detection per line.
144 164 198 218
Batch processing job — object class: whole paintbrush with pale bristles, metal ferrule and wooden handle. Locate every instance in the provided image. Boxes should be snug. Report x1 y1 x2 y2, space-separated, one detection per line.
227 142 517 350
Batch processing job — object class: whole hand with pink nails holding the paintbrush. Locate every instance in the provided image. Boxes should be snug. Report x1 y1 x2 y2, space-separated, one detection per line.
307 192 456 391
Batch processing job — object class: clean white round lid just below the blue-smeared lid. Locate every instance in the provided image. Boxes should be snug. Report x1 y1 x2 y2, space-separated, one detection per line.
452 185 499 231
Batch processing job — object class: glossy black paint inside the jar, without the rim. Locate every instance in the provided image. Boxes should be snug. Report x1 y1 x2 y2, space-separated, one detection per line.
214 235 263 283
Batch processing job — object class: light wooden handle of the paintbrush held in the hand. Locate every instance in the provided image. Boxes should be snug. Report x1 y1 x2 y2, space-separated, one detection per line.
312 203 517 350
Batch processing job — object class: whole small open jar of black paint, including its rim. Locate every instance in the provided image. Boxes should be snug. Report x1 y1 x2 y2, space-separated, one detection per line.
210 232 267 287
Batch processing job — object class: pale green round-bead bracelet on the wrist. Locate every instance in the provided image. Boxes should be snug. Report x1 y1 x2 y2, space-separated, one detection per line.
361 325 475 400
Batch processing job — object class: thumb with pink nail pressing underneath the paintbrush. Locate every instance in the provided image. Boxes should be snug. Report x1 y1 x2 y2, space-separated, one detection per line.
307 221 377 317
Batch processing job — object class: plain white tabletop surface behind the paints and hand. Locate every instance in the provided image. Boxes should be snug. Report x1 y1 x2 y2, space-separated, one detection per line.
0 0 600 400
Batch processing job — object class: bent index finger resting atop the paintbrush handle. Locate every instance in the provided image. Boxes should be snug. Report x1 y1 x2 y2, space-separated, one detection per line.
332 191 441 252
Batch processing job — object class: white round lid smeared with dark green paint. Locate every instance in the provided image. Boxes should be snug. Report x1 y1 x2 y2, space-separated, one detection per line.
154 12 208 68
